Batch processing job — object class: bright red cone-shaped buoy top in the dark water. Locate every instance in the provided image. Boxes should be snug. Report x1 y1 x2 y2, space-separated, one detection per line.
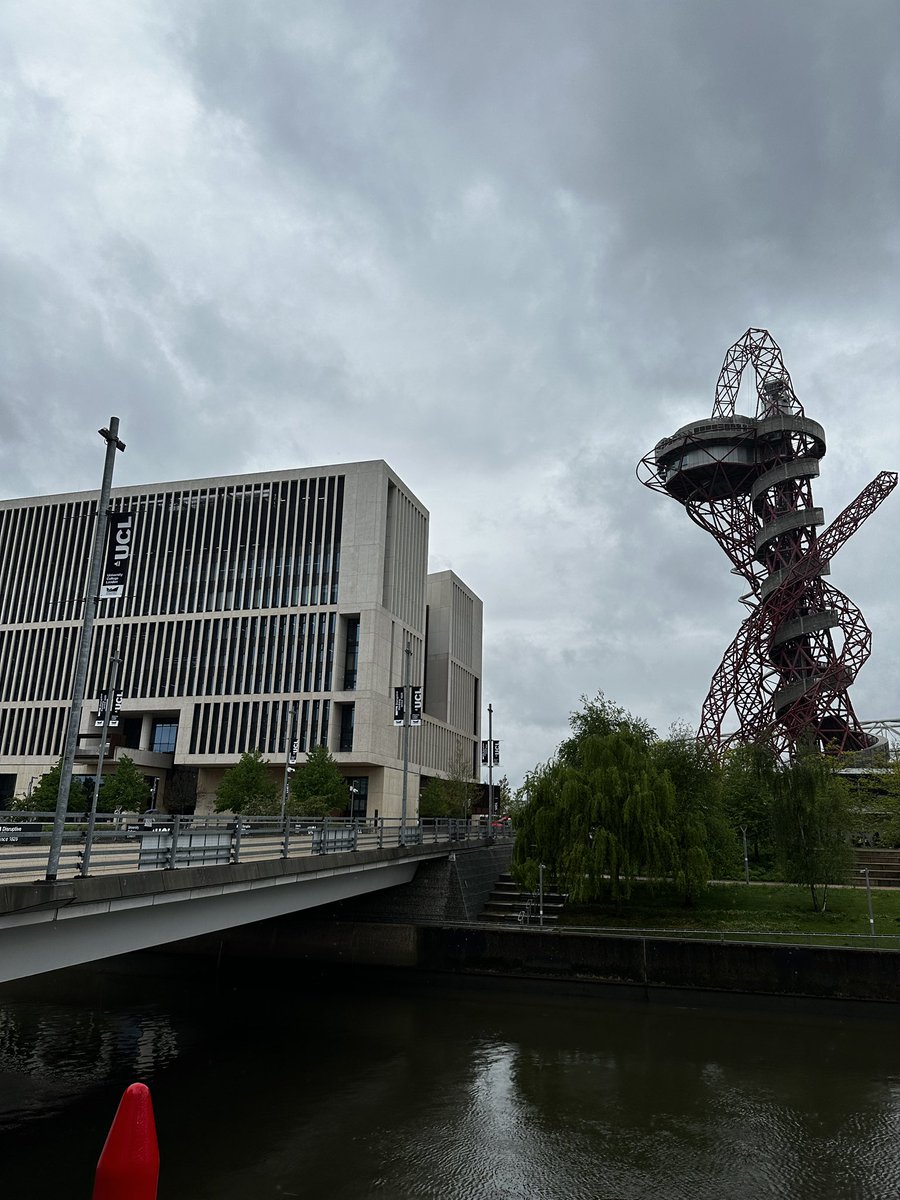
92 1084 160 1200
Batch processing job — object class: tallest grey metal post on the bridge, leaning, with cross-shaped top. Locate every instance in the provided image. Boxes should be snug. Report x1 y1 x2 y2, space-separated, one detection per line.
46 416 125 883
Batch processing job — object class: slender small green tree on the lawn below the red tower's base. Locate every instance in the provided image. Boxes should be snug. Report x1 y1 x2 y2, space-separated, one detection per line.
772 754 853 912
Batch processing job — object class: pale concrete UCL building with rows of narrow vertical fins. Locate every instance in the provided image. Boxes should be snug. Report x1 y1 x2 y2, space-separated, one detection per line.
0 461 482 817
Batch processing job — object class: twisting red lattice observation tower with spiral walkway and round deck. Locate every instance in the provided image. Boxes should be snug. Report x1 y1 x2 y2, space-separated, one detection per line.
637 329 898 757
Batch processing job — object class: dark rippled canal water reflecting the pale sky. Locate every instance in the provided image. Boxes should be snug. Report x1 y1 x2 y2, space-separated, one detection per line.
0 956 900 1200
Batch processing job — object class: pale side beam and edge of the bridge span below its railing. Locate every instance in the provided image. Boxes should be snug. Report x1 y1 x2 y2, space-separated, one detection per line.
0 846 449 983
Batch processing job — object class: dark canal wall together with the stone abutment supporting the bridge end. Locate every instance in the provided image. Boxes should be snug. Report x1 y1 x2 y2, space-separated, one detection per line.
157 844 900 1003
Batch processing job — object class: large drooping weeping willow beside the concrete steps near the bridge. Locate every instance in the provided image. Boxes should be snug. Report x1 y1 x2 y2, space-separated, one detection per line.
514 696 724 902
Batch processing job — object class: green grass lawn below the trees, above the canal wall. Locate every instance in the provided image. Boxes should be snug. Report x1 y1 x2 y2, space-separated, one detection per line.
559 883 900 949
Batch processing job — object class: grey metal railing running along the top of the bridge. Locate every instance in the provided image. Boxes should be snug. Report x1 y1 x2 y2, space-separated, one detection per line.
0 811 512 884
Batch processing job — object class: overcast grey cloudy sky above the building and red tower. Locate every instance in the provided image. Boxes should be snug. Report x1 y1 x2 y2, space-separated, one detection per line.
0 0 900 785
